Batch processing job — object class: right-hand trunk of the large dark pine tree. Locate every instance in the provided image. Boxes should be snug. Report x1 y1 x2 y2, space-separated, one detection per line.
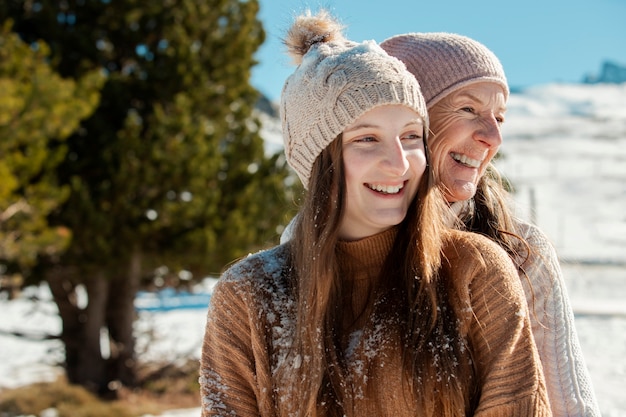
107 249 141 386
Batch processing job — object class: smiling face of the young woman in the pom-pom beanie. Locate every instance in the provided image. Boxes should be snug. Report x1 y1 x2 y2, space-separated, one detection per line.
339 105 426 240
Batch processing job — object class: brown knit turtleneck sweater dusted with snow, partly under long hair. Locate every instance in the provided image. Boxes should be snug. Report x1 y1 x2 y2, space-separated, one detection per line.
200 229 552 417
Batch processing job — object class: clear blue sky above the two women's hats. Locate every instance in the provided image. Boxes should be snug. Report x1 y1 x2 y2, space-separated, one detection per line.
251 0 626 101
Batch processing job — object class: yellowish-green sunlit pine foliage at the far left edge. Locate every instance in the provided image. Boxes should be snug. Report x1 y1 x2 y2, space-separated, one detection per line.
0 22 104 296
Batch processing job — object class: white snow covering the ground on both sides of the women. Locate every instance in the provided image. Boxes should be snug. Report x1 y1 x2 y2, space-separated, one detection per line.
0 84 626 417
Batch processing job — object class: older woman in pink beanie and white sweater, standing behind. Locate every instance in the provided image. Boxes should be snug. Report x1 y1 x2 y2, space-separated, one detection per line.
381 33 600 417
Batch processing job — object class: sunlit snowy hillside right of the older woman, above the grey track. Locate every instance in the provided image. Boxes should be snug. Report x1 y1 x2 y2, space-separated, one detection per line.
496 83 626 265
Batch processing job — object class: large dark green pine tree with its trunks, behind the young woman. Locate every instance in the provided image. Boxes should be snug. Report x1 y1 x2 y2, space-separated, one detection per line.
0 0 287 395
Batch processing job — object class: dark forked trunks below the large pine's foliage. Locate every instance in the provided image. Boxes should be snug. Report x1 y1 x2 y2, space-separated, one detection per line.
47 249 141 399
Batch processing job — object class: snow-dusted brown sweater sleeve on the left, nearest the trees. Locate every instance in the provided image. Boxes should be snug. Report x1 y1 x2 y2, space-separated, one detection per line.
200 246 293 417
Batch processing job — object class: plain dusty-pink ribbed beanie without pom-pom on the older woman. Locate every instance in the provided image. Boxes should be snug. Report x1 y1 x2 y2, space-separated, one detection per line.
380 32 509 108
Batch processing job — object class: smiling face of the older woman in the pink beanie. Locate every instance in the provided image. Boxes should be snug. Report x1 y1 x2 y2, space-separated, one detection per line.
428 82 506 203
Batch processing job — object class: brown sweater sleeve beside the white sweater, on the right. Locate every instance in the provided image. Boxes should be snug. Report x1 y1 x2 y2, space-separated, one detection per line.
444 231 552 417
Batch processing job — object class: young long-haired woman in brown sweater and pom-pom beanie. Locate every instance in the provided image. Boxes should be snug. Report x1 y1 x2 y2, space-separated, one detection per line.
200 12 551 417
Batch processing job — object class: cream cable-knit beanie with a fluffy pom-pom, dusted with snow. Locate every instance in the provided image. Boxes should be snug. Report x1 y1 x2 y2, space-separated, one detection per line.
280 11 428 188
